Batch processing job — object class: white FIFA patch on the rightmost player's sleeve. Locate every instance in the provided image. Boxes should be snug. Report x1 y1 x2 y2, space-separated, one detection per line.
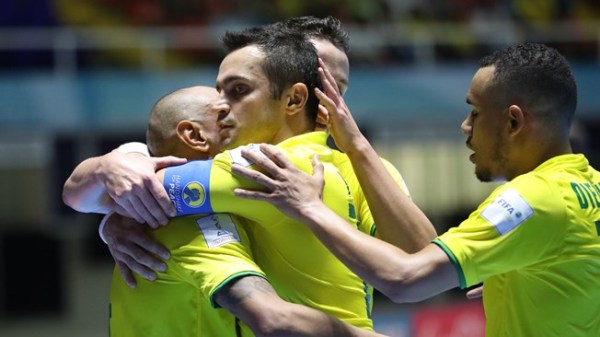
481 189 534 235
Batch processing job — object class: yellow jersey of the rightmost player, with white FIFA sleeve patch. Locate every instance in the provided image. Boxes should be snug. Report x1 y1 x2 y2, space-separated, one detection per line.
434 155 600 337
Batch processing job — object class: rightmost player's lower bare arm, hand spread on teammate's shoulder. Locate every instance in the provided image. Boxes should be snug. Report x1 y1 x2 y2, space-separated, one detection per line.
233 145 459 302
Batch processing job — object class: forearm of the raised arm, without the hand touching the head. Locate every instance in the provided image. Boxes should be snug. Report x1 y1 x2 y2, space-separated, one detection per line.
347 138 437 253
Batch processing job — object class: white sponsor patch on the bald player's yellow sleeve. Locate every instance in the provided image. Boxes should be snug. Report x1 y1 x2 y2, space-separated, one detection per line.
196 214 241 248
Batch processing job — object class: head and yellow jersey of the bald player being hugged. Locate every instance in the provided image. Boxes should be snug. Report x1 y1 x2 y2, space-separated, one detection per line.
103 86 266 337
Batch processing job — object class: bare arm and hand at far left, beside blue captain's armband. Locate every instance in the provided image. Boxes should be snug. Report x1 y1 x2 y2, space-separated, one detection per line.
63 146 186 228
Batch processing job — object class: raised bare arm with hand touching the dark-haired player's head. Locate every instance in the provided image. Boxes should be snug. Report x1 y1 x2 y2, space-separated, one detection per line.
317 61 436 252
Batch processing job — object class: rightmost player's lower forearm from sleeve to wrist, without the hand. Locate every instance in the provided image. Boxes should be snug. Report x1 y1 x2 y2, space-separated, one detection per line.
299 202 459 302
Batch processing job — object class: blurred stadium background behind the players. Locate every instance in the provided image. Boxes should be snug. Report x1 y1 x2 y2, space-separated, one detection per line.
0 0 600 337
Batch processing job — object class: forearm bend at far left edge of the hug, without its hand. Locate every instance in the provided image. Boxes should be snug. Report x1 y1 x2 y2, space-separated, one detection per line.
62 157 111 213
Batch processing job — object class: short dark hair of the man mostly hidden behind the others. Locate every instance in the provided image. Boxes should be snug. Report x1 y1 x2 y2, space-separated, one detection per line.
273 16 350 54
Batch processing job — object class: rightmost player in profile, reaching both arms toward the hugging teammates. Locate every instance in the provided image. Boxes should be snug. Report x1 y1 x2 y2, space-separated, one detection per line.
234 43 600 337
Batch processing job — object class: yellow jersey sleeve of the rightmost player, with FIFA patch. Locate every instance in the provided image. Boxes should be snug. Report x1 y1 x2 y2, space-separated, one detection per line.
434 175 566 288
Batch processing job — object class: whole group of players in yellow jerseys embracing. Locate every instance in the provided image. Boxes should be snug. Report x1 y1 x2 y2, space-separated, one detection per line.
63 13 600 337
